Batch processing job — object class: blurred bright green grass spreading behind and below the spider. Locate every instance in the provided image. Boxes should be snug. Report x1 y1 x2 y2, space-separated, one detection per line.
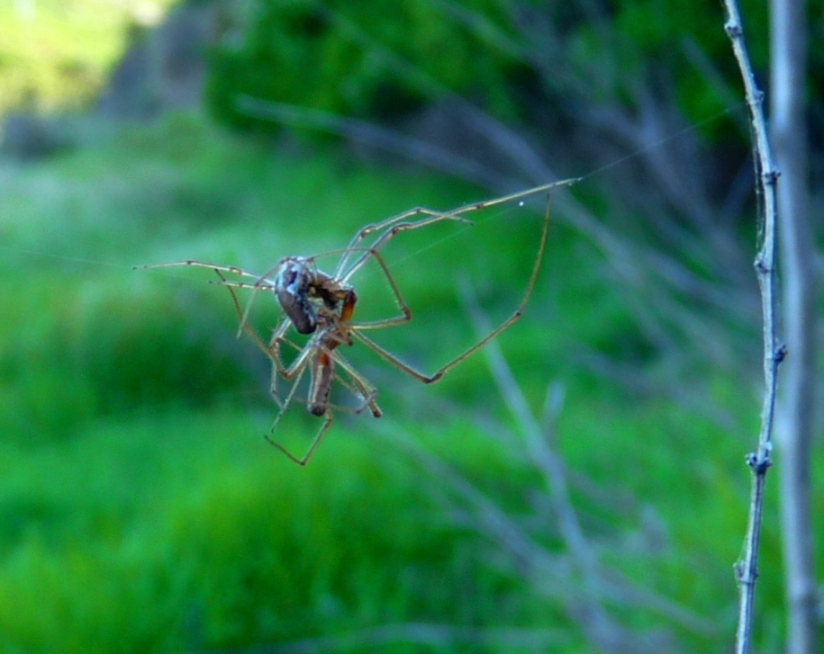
0 114 824 652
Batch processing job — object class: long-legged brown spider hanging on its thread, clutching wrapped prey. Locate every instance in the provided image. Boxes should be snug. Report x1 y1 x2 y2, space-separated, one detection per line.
142 178 579 465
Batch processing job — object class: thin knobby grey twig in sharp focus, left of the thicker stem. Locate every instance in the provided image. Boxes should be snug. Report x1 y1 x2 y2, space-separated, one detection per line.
724 0 785 654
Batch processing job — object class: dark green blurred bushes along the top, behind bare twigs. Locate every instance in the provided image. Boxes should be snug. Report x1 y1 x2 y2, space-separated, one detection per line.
207 0 792 136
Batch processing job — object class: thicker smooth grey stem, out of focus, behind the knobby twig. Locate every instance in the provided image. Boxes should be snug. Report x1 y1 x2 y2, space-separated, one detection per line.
770 0 818 654
